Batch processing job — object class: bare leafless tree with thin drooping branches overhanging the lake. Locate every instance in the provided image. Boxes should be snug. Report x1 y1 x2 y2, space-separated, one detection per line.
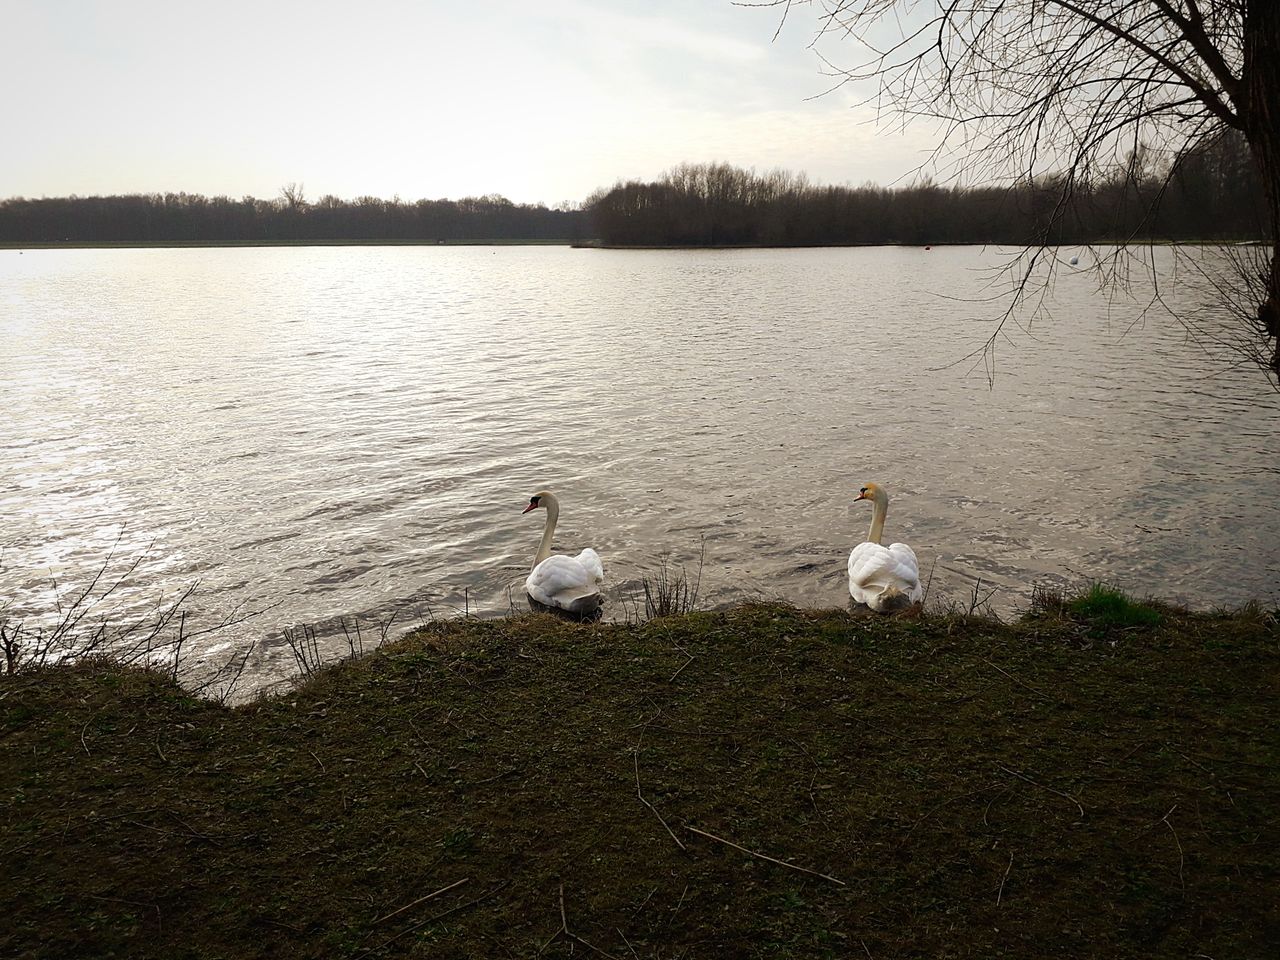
740 0 1280 374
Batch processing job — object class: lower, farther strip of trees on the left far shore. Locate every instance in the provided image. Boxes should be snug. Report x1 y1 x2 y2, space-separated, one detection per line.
0 184 589 243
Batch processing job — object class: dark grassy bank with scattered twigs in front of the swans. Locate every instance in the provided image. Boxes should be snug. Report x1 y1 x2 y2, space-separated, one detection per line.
0 602 1280 960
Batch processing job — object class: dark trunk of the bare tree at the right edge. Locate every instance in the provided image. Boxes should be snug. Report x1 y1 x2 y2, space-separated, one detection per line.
1240 0 1280 375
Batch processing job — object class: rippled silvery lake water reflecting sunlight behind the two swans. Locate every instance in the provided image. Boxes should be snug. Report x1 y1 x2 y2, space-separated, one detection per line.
0 247 1280 684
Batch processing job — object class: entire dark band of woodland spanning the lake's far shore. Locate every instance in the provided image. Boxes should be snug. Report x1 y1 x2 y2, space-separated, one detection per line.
0 137 1266 246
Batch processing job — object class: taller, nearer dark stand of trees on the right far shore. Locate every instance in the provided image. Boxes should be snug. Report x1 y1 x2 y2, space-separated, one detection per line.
586 136 1268 246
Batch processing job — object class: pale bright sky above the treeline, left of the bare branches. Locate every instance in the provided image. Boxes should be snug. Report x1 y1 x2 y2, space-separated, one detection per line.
0 0 932 205
